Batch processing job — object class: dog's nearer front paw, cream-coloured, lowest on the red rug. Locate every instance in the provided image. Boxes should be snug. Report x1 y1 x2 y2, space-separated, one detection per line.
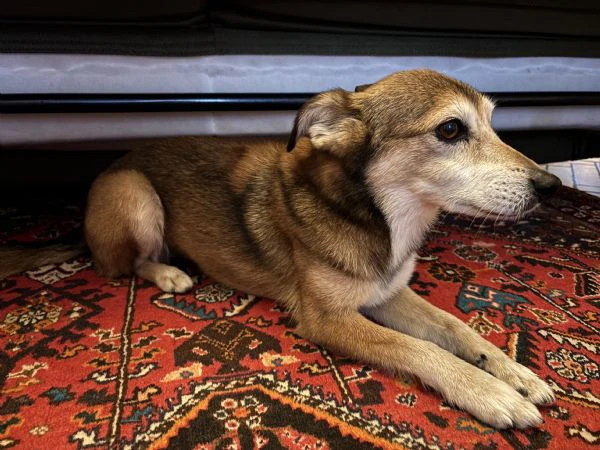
444 371 543 429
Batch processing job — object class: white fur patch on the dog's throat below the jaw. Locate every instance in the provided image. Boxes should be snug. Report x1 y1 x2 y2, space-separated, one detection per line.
375 187 439 271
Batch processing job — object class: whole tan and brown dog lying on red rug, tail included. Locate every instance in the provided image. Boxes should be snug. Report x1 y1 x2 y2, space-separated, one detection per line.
0 70 560 429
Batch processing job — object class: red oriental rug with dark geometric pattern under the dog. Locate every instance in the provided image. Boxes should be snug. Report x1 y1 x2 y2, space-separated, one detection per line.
0 185 600 450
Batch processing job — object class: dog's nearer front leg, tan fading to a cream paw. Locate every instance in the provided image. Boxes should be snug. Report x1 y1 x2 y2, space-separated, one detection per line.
296 299 542 428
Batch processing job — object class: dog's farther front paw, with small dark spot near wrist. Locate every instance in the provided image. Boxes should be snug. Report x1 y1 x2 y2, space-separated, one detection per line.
476 350 554 405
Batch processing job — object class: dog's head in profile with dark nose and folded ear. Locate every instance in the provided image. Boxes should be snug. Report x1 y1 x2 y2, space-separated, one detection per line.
288 70 560 218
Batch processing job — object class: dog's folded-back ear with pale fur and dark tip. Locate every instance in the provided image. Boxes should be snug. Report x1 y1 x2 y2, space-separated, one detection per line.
287 89 367 154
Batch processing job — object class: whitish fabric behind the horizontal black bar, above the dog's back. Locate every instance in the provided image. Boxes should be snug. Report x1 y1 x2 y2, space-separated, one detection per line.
0 54 600 145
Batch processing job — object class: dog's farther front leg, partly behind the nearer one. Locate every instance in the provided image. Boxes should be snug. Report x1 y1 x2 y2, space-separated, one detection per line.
364 287 554 404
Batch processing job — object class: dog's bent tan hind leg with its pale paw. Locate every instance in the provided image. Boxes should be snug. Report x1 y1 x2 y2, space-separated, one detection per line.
85 170 193 292
